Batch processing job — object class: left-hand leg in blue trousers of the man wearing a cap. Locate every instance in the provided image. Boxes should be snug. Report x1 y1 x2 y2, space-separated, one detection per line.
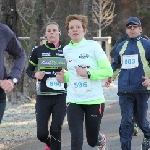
118 93 134 150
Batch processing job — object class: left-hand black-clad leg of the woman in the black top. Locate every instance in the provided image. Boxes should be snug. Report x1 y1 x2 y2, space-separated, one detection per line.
36 95 51 147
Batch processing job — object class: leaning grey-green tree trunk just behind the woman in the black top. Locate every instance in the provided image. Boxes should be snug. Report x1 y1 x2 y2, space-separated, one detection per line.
23 0 46 99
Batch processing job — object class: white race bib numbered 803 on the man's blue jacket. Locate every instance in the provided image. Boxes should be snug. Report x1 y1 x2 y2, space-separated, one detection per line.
121 54 139 69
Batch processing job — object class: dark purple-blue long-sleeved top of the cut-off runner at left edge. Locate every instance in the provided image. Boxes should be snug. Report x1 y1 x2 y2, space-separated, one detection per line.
0 23 26 80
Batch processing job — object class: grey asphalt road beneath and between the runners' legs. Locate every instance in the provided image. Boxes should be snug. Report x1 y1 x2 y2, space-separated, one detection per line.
9 102 150 150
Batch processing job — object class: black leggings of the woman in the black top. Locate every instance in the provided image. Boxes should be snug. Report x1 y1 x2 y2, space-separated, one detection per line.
35 94 66 150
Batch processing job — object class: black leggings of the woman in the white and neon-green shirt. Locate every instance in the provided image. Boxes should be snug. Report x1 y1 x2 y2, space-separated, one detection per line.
67 103 104 150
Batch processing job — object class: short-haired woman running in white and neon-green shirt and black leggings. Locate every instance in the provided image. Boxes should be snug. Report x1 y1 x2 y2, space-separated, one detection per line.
56 15 112 150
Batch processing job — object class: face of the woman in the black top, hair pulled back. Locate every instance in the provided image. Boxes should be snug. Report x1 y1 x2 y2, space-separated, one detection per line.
45 24 60 45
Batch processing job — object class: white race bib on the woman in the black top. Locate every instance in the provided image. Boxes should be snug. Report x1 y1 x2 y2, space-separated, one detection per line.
46 77 65 90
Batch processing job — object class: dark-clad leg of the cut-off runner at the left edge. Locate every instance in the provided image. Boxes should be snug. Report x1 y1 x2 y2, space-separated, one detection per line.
0 89 6 124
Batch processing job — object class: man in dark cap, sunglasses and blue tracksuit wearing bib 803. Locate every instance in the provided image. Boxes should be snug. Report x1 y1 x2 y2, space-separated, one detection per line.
106 17 150 150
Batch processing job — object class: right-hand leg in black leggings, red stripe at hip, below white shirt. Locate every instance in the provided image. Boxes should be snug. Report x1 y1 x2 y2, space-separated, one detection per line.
85 104 104 147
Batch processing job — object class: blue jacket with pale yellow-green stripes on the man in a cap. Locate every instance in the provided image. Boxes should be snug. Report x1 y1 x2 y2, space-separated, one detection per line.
112 36 150 92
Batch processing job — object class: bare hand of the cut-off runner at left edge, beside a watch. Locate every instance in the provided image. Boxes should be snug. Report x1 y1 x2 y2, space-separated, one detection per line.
0 79 15 92
